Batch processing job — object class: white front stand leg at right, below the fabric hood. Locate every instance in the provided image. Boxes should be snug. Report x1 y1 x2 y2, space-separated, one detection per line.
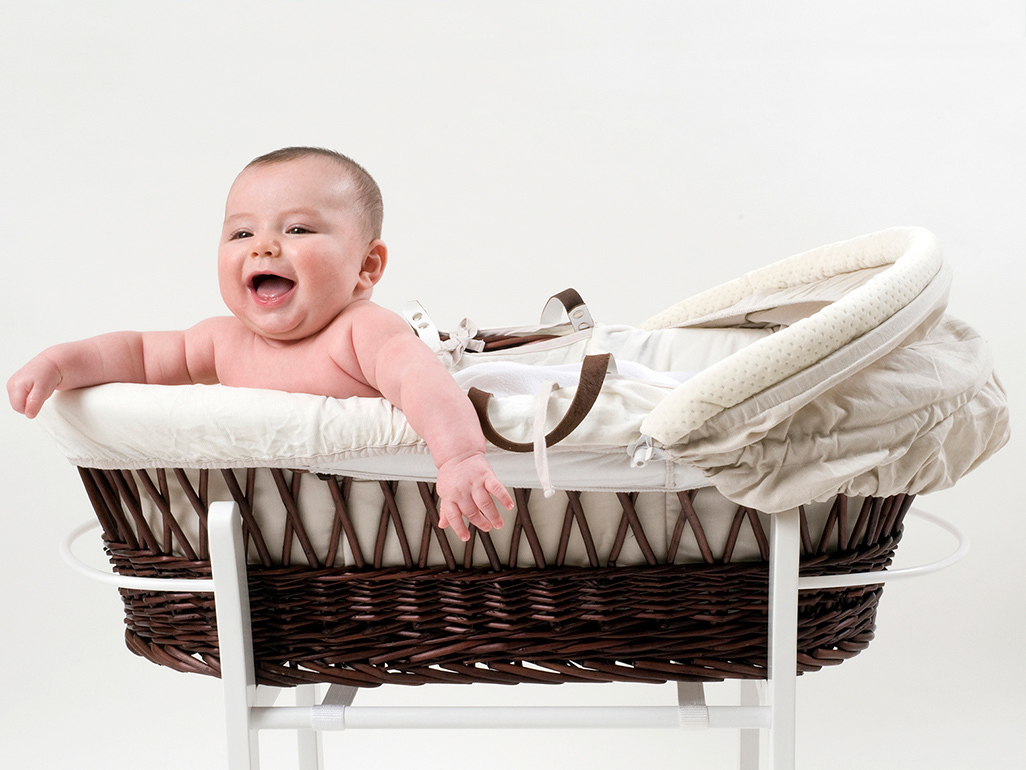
767 509 800 770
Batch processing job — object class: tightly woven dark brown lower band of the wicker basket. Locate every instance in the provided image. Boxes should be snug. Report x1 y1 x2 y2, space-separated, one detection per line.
116 558 894 687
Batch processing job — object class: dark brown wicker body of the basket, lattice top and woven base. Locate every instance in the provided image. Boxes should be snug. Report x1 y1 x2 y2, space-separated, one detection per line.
80 468 912 687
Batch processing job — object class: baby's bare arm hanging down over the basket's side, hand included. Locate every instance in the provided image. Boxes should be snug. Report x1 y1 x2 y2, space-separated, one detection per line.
352 303 513 540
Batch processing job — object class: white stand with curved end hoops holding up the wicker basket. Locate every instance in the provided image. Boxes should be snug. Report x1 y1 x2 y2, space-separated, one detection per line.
62 502 969 770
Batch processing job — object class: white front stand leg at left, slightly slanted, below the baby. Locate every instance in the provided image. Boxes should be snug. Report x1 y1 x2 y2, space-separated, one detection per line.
207 502 260 770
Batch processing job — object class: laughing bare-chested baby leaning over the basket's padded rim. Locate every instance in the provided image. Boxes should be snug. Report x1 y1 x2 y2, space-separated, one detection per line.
7 147 513 540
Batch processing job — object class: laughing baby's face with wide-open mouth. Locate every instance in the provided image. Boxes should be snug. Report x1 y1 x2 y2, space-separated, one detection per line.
218 156 385 342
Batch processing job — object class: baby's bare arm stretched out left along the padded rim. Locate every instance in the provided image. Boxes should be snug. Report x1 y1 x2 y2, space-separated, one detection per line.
7 322 216 417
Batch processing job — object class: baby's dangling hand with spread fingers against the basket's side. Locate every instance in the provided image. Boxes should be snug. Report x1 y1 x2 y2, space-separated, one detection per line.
435 452 513 541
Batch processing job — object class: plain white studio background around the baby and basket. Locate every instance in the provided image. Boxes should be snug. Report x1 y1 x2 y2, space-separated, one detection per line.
0 0 1026 770
